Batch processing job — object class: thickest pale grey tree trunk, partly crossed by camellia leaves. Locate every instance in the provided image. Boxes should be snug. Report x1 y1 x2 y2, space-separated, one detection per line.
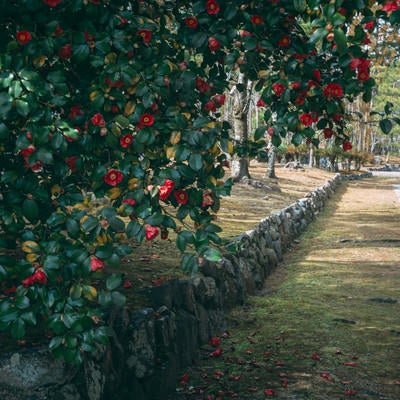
231 74 252 182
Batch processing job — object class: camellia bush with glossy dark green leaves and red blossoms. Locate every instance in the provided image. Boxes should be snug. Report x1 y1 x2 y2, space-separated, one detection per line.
0 0 398 363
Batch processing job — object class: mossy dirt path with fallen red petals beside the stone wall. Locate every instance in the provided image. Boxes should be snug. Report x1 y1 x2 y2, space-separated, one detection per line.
173 178 400 400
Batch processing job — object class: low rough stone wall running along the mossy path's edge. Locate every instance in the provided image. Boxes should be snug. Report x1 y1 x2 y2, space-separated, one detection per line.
0 174 370 400
